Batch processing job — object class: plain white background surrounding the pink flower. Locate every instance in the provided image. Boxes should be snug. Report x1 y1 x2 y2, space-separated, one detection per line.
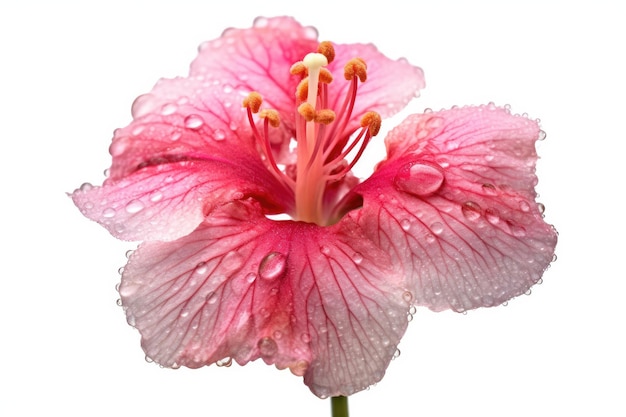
0 0 626 417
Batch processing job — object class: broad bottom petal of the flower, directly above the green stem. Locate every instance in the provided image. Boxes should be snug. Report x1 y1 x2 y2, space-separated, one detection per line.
120 200 410 397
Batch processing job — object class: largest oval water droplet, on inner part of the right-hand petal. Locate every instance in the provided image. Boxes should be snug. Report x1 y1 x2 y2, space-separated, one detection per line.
394 161 444 196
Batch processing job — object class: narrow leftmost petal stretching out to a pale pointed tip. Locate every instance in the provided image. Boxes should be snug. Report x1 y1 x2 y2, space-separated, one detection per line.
72 158 293 241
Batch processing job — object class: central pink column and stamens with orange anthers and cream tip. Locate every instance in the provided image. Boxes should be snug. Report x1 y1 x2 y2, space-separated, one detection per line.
243 42 381 226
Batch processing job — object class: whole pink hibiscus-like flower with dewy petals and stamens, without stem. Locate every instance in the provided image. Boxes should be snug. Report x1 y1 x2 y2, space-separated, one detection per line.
72 18 556 397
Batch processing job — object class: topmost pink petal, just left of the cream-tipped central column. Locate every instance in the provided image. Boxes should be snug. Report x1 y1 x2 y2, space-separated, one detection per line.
190 17 318 158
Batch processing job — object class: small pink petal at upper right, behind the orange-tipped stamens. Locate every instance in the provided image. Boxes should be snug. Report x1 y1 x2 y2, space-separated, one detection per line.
328 44 425 121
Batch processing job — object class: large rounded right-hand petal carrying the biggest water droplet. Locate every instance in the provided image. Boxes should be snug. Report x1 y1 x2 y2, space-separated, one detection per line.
351 106 557 311
